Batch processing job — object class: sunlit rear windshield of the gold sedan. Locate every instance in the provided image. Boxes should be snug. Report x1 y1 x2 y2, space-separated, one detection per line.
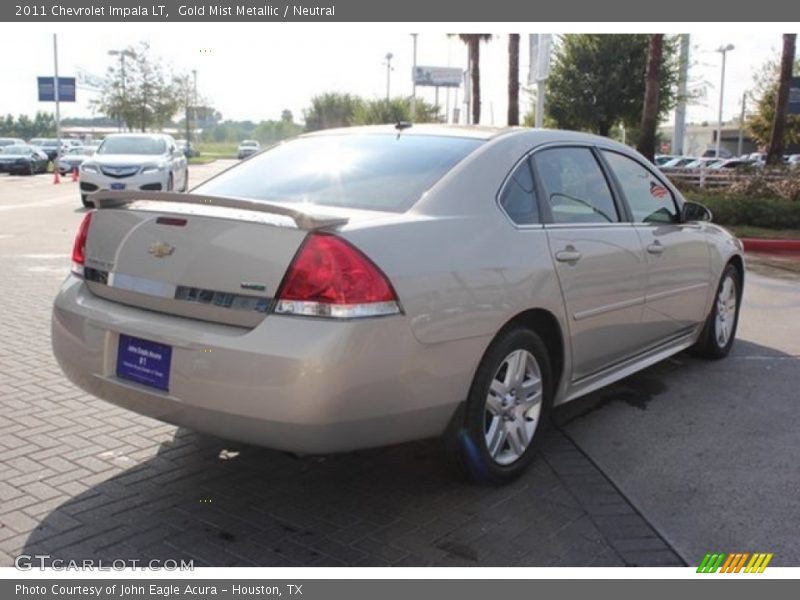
195 134 483 212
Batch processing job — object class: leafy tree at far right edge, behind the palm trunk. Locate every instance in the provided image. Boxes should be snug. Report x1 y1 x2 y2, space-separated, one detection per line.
745 58 800 146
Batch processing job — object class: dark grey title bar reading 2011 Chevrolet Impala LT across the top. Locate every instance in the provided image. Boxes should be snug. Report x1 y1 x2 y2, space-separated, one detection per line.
0 0 800 21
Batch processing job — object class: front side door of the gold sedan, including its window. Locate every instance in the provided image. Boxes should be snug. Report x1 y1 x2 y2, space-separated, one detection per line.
601 150 715 344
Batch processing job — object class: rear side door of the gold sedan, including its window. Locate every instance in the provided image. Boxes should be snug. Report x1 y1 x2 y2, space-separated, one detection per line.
533 146 647 380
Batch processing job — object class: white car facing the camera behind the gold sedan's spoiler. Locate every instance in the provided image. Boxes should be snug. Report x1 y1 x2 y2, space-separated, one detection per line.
80 133 189 206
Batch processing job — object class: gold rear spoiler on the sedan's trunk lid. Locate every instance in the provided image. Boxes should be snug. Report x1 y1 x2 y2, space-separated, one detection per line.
87 190 348 231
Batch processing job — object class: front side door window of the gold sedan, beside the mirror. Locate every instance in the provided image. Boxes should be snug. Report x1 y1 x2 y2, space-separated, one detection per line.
603 151 678 223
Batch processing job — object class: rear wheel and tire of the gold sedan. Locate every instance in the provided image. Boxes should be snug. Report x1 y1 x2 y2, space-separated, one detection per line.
444 328 553 485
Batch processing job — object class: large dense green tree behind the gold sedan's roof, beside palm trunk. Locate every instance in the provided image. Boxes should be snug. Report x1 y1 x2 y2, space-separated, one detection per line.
546 34 678 135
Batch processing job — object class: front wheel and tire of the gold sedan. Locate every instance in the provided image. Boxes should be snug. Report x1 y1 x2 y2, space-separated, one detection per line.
691 264 742 359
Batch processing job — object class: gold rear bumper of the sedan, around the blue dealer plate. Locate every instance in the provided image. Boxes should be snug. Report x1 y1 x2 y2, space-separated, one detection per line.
52 276 488 453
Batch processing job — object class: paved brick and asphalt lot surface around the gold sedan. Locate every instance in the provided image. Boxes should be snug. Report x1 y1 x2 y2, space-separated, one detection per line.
0 168 800 566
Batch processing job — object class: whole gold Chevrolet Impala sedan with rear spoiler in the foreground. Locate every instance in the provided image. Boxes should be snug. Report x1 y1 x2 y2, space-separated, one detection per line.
53 124 744 482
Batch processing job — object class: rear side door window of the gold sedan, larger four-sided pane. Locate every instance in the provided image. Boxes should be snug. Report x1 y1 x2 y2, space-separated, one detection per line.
535 148 619 223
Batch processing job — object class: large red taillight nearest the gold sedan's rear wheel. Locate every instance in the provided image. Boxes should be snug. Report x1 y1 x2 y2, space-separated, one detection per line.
275 233 400 319
